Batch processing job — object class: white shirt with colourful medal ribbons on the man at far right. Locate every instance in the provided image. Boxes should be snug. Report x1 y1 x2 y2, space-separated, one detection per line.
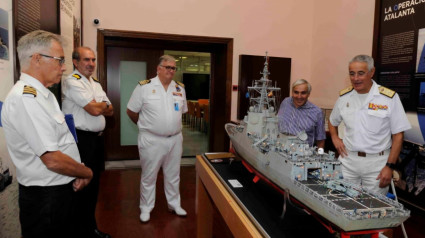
329 81 411 153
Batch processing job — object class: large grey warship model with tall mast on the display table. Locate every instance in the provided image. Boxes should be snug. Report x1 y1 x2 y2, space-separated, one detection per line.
225 52 410 232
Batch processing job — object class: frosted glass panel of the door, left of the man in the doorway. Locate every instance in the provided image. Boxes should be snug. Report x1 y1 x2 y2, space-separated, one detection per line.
119 61 146 146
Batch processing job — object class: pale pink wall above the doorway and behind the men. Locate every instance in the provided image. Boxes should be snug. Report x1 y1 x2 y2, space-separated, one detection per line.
83 0 374 119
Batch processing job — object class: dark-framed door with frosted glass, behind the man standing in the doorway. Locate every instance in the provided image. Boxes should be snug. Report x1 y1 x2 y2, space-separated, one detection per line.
105 47 163 160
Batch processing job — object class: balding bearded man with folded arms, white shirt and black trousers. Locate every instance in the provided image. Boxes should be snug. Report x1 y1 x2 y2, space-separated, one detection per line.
62 47 114 238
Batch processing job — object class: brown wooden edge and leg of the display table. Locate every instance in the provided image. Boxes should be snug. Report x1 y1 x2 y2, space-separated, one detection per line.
196 153 262 237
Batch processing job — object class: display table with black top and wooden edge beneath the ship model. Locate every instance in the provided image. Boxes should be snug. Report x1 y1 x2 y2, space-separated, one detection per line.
196 153 333 237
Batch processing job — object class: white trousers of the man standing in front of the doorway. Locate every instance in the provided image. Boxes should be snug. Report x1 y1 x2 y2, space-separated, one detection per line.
138 132 183 212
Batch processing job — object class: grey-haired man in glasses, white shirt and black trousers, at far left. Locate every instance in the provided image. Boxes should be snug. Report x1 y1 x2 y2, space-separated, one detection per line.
1 31 92 238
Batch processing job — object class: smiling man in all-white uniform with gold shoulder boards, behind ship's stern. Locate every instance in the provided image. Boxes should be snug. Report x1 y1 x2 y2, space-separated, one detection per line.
329 55 411 195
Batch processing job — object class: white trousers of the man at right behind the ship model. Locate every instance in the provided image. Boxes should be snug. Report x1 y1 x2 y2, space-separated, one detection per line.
338 149 390 196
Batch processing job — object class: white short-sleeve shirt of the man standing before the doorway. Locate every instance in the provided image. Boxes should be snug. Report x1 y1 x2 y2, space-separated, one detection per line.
127 76 187 136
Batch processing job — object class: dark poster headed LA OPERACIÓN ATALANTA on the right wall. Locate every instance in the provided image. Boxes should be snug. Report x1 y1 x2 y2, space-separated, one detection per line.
376 0 425 145
